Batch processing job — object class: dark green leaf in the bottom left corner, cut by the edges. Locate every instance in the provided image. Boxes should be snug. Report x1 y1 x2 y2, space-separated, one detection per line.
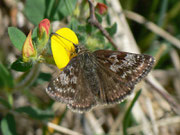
1 114 17 135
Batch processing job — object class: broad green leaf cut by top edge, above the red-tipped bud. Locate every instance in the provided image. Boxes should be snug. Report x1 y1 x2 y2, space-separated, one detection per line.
24 0 46 25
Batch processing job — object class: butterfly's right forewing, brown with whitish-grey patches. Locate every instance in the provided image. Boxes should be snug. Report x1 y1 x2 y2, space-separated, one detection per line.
94 50 154 83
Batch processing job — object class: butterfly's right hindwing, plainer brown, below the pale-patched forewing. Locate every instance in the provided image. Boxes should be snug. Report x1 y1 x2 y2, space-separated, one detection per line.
94 65 134 104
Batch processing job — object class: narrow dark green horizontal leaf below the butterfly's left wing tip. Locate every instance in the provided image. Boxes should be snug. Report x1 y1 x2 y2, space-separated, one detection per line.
15 106 54 120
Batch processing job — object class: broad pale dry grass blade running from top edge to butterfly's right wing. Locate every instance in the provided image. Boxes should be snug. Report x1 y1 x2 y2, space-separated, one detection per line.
109 0 140 53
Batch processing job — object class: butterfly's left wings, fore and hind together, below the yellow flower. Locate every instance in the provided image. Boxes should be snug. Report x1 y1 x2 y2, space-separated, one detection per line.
46 56 96 112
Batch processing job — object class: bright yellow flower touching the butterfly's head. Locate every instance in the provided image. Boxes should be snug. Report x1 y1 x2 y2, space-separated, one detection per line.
51 28 78 69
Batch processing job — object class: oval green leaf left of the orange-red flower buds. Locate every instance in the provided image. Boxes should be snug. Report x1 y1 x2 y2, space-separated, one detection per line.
8 27 26 51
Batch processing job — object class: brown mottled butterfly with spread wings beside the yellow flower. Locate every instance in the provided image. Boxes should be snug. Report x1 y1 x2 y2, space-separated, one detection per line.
46 34 155 112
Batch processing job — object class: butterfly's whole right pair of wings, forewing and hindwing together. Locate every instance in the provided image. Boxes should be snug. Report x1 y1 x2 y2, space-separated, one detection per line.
94 50 154 104
